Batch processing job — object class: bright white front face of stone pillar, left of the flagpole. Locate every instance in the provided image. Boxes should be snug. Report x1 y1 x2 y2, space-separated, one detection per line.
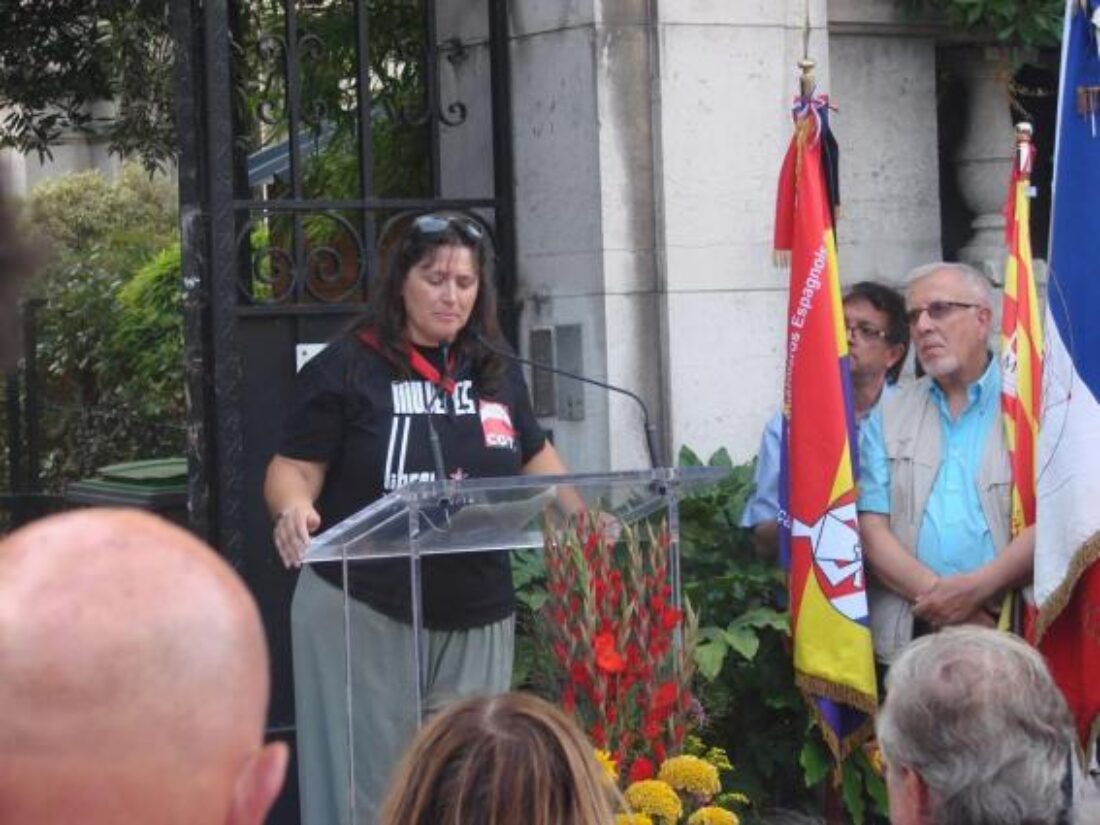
657 0 831 461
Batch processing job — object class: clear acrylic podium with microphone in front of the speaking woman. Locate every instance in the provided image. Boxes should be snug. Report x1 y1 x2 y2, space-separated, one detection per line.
304 468 726 825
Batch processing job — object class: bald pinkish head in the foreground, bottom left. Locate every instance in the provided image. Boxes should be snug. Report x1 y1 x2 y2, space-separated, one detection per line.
0 509 287 825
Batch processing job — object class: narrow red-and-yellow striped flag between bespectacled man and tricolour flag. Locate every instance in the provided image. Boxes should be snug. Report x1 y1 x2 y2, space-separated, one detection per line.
1001 124 1043 536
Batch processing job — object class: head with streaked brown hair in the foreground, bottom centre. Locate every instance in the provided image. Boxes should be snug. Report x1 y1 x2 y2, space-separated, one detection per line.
381 693 615 825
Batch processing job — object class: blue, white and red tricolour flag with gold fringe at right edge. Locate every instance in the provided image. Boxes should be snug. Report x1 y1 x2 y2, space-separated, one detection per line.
1034 0 1100 761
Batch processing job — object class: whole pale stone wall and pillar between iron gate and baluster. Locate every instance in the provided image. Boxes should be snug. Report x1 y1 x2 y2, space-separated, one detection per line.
513 0 939 470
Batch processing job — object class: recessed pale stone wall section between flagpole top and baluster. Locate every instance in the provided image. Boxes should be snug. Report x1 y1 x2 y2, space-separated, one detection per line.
829 0 943 284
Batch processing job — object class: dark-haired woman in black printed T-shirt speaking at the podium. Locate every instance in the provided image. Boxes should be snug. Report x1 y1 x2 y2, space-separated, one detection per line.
264 212 565 825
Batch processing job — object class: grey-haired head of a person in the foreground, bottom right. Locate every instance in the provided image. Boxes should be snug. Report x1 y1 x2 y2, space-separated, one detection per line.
876 627 1074 825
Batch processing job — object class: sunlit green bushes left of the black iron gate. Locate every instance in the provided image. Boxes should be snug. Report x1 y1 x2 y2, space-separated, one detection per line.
20 166 185 492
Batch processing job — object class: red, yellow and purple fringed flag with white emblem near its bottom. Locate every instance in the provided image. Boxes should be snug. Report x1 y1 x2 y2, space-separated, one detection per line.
776 96 877 759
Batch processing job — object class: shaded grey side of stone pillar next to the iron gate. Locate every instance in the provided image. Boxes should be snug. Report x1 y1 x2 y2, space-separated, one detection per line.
512 0 662 471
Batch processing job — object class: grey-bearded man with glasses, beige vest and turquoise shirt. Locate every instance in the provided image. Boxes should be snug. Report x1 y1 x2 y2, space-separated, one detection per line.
859 263 1034 664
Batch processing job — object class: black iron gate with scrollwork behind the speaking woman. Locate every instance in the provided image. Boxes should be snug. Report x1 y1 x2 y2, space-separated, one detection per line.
172 0 515 822
